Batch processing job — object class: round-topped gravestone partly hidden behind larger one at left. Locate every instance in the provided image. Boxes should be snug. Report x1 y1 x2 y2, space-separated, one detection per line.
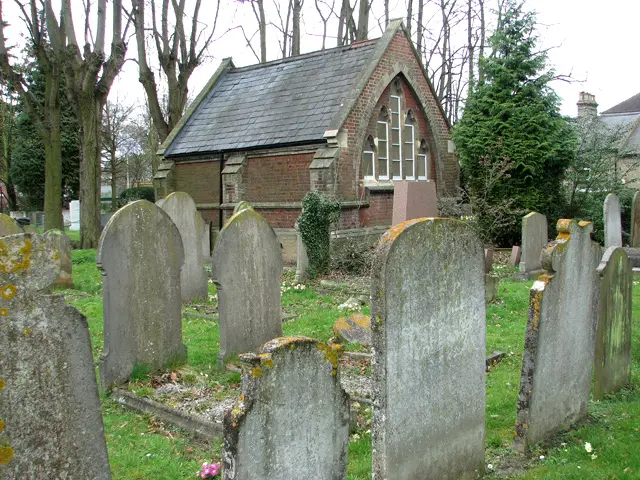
156 192 208 302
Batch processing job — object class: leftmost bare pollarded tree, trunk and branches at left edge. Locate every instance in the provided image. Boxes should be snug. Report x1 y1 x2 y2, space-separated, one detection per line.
0 0 65 230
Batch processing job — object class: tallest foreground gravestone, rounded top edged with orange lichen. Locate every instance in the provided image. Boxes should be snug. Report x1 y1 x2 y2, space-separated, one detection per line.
371 218 485 480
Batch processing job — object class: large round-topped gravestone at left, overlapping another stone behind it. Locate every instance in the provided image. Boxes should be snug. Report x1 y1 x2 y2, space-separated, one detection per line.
96 200 187 388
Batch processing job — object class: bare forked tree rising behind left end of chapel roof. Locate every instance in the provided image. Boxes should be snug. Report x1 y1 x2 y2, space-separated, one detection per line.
131 0 220 142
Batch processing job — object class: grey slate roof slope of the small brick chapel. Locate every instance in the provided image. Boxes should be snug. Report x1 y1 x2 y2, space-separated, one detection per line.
164 41 376 157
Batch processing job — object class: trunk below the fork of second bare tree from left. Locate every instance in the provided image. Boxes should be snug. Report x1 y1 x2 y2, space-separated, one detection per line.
80 95 102 248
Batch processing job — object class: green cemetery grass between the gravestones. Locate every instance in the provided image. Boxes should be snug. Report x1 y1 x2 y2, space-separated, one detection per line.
63 250 640 480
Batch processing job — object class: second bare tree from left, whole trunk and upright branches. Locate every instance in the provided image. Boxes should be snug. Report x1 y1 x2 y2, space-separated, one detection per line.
43 0 128 248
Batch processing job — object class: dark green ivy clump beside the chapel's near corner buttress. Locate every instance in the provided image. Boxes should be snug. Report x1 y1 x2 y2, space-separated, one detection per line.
297 190 340 277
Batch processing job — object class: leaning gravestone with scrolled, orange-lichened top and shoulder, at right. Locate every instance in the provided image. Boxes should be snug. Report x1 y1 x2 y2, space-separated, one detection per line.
514 220 600 452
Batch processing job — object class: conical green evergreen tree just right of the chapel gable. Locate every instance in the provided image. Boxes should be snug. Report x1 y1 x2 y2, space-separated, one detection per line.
453 0 575 245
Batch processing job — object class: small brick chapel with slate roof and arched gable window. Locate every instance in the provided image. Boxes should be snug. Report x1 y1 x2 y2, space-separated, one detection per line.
154 20 459 260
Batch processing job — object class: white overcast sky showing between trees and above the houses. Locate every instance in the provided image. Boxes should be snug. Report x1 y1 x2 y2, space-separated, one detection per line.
5 0 640 116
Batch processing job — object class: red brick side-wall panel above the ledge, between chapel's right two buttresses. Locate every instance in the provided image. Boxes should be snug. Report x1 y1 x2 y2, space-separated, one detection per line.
244 153 314 201
